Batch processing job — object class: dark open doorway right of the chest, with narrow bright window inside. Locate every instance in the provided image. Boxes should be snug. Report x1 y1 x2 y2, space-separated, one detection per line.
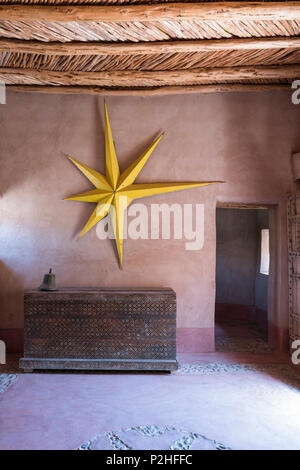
215 207 270 353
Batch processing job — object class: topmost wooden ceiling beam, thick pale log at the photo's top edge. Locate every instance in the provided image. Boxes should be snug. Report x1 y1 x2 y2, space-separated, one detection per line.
0 1 300 22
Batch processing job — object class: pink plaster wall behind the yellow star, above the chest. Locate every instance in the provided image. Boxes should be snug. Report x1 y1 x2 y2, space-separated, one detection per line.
0 91 300 349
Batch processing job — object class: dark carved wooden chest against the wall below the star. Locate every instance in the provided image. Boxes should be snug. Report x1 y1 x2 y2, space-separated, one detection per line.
20 288 177 371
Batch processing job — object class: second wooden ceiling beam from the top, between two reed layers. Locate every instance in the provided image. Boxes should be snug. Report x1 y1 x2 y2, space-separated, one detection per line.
0 37 300 56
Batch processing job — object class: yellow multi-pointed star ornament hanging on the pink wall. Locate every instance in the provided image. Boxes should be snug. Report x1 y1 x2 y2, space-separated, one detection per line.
66 103 221 267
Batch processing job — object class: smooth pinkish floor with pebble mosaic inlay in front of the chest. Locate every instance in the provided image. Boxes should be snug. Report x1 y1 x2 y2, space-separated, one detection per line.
0 352 300 449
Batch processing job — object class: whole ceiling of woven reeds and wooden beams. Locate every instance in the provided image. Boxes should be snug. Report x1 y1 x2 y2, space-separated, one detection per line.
0 0 300 93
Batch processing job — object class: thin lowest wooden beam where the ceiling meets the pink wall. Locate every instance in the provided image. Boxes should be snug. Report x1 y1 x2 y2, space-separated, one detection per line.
7 84 290 96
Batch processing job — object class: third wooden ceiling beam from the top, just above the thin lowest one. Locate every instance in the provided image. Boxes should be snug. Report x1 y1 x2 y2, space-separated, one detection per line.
0 64 300 87
